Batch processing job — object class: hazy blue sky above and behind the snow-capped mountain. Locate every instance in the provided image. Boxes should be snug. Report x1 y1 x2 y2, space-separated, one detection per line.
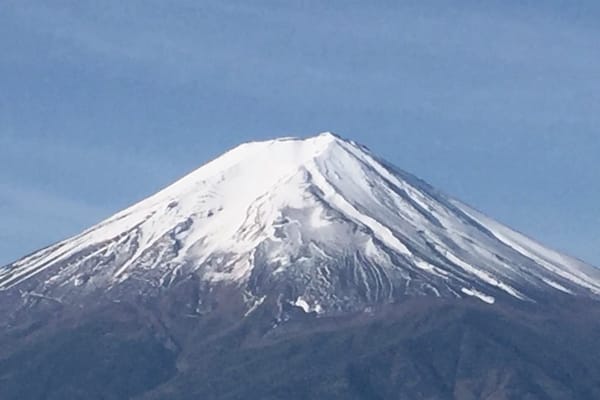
0 0 600 266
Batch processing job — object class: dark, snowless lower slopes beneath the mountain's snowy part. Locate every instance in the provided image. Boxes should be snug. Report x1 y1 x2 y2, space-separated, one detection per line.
0 298 600 400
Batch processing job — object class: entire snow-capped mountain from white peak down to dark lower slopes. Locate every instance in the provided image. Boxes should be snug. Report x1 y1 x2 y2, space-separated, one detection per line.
0 133 600 399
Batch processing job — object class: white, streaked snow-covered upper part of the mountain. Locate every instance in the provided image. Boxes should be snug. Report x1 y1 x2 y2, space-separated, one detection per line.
0 133 600 313
